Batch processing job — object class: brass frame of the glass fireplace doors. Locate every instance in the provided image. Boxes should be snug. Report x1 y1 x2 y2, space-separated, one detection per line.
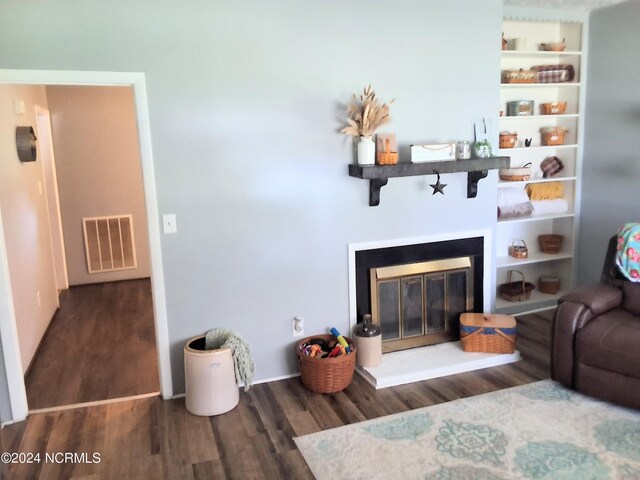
369 256 474 353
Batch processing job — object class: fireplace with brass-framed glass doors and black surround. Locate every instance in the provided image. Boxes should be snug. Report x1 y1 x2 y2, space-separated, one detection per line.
355 237 484 352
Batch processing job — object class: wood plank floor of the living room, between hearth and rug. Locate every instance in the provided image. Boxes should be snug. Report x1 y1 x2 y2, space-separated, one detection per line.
2 312 551 480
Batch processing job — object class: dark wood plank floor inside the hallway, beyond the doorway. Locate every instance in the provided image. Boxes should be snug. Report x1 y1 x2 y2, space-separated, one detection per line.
25 279 160 410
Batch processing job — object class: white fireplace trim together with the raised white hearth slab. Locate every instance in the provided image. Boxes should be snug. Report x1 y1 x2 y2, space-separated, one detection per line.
349 230 520 388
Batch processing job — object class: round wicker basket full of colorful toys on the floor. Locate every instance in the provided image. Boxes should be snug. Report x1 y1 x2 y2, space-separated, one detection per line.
296 329 356 393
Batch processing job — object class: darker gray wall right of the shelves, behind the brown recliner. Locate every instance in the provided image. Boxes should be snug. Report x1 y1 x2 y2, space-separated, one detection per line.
578 0 640 284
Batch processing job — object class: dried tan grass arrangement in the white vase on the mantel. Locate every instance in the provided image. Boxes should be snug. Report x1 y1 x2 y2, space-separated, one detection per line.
340 85 395 137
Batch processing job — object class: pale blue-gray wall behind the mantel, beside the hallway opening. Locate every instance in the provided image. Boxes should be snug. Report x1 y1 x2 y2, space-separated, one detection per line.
0 0 502 392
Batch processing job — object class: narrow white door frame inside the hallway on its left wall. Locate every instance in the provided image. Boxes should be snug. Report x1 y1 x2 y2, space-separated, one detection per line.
36 105 69 292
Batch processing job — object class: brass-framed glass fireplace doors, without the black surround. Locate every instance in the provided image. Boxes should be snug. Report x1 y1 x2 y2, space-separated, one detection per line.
370 257 473 352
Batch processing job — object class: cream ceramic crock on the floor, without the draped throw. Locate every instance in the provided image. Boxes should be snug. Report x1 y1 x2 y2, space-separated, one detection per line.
184 335 240 417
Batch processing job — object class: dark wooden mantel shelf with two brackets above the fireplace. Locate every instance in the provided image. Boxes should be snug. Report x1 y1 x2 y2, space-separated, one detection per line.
349 157 511 207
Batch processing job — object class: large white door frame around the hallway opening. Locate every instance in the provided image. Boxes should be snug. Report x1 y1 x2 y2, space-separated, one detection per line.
0 70 173 422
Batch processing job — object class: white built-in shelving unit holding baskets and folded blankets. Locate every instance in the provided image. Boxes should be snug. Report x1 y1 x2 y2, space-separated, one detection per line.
495 20 584 314
